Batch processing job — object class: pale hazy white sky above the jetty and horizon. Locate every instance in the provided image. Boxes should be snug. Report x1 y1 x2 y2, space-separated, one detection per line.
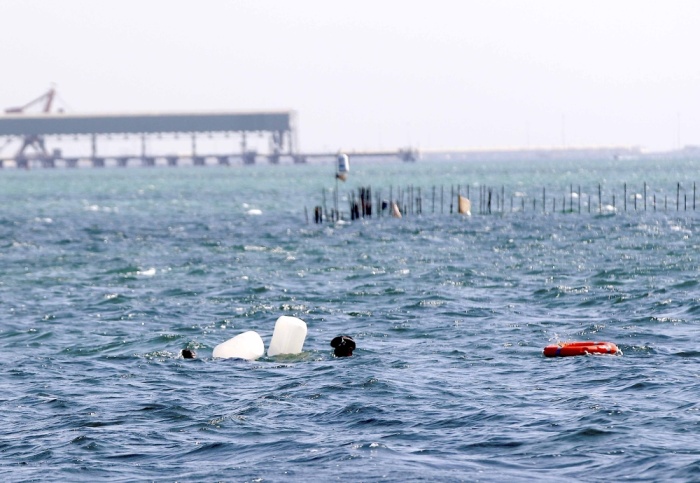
0 0 700 151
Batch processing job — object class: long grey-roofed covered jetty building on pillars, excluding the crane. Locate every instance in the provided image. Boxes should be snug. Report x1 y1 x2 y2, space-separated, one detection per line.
0 111 296 168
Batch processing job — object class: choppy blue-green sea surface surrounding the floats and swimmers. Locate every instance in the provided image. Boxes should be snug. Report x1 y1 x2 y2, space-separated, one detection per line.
0 159 700 482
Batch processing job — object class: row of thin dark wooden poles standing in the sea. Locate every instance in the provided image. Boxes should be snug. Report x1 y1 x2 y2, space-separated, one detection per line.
305 182 696 223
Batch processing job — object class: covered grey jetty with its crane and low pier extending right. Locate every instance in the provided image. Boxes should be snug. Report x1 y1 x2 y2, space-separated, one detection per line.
0 88 418 169
